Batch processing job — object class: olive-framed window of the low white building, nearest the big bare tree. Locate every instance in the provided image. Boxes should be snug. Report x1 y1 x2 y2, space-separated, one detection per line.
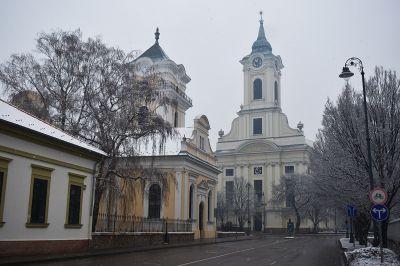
65 173 86 228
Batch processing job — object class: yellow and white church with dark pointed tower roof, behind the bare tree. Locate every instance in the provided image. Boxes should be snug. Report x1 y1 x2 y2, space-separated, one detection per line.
96 29 221 239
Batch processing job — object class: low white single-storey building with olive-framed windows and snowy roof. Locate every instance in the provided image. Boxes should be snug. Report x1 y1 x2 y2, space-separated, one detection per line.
0 100 105 257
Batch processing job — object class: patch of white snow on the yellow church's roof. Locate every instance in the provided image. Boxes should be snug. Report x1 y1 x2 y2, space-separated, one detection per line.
135 127 193 156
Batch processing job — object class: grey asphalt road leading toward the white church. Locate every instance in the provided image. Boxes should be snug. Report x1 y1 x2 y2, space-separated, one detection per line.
36 235 342 266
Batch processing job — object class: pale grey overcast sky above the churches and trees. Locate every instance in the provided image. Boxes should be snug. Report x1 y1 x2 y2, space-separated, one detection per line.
0 0 400 150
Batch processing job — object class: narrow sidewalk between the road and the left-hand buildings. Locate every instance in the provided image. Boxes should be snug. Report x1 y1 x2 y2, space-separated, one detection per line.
0 235 254 265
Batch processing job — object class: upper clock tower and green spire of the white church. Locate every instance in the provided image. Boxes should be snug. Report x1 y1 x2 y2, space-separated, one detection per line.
240 14 283 110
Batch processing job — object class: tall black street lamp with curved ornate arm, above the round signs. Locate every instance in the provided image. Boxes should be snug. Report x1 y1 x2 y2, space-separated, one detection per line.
339 57 374 190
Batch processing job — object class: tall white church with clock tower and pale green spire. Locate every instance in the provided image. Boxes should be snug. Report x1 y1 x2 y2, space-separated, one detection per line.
216 19 311 231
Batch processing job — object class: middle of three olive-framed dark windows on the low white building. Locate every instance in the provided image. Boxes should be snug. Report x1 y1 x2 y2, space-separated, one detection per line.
26 164 54 227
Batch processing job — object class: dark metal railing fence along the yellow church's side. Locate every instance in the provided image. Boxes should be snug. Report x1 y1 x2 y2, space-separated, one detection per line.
95 213 194 232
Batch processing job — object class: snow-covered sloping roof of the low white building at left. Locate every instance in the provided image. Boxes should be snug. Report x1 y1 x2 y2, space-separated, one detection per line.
0 99 107 155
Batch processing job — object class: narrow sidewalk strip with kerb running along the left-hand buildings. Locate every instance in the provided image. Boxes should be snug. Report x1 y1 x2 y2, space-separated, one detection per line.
0 237 254 265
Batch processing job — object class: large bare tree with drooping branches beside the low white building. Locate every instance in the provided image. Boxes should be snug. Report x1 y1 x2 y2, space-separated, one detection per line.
0 30 174 228
